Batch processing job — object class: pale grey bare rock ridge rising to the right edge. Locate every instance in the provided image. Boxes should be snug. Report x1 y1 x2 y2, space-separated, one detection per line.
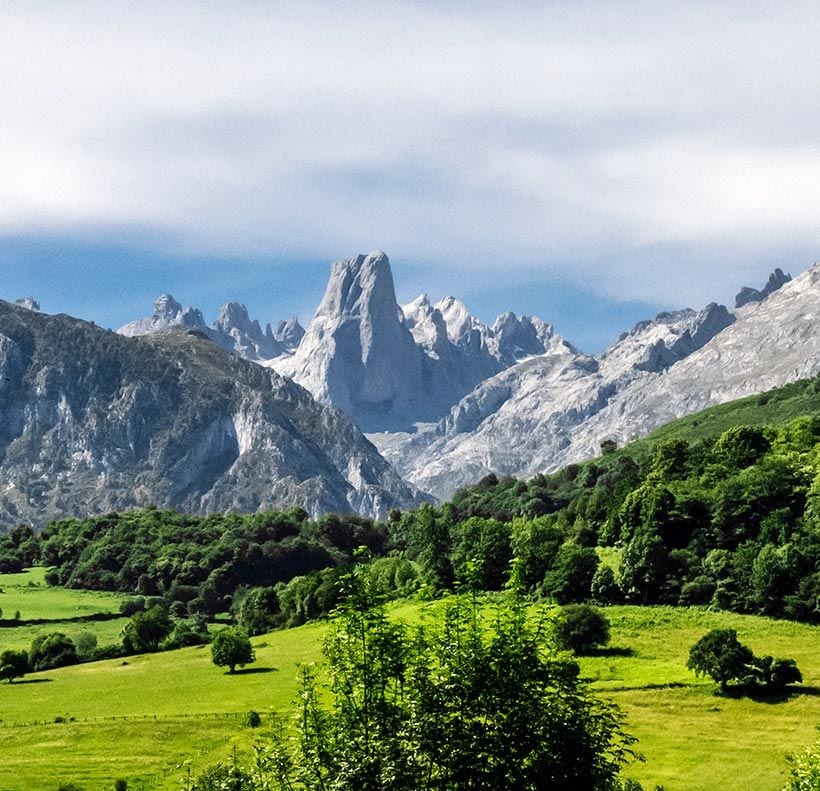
375 265 820 497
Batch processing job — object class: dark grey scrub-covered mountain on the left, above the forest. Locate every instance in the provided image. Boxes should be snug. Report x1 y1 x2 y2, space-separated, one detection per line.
0 299 419 526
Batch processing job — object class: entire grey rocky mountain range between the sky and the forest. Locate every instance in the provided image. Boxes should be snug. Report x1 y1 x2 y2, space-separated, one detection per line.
0 251 820 524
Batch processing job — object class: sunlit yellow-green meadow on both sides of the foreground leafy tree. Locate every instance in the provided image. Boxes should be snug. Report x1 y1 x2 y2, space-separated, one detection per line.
0 588 820 791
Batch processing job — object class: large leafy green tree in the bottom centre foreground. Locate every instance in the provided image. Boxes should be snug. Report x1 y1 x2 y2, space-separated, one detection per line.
269 578 632 791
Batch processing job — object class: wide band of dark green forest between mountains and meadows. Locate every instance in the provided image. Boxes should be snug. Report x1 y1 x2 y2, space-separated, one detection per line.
0 379 820 633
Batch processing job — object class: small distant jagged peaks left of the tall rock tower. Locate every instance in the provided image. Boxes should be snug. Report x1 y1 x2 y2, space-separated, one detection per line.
117 294 304 361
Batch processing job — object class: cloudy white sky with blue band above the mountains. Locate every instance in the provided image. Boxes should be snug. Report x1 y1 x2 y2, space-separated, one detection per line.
0 0 820 350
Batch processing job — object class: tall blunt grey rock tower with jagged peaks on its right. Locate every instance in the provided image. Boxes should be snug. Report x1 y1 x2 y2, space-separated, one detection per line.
271 251 573 432
